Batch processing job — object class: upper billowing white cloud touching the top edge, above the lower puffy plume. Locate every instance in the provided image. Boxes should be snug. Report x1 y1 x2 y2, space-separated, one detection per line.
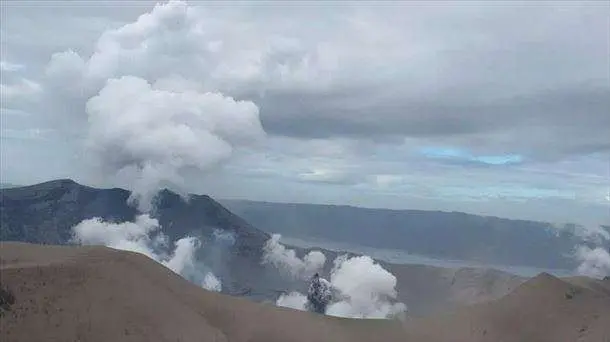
47 0 329 97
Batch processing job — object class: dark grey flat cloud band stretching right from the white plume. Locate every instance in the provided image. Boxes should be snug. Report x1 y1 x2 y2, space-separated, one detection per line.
261 81 610 156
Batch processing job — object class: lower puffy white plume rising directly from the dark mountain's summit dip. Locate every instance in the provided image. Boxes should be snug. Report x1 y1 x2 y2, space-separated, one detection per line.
87 76 264 209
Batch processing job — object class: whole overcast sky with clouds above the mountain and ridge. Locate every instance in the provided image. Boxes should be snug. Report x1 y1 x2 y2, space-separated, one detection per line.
0 1 610 224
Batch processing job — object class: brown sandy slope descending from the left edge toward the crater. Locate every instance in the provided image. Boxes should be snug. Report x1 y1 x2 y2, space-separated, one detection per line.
0 243 401 342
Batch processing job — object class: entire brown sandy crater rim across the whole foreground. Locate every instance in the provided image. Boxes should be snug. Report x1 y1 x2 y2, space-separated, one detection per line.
0 243 610 342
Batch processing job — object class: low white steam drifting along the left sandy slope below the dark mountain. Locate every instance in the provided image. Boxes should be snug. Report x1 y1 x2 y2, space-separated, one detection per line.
72 214 222 291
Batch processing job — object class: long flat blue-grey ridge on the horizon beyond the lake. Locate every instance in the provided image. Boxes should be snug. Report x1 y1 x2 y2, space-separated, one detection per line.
220 200 610 269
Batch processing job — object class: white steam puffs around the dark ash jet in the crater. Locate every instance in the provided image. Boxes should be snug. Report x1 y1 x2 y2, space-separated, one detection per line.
263 234 407 318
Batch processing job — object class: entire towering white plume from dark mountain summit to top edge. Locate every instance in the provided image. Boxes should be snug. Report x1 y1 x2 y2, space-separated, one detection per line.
46 1 265 212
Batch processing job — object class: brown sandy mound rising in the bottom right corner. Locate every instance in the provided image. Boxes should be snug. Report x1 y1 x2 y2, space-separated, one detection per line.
409 273 610 342
